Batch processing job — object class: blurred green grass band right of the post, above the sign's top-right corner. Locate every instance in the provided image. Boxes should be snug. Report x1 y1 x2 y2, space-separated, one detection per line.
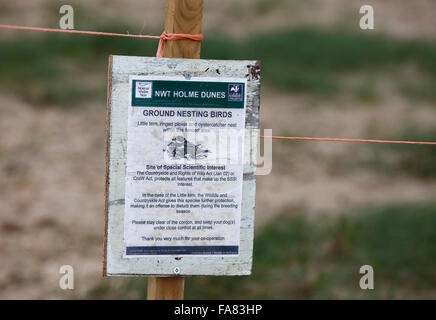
202 29 436 98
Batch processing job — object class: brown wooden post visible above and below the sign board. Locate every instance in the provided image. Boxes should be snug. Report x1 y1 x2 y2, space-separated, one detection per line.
147 0 203 300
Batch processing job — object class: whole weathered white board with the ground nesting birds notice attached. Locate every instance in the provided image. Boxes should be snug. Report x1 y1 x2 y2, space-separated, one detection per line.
104 56 260 276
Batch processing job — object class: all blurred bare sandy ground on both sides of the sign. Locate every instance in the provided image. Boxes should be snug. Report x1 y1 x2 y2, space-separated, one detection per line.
0 0 436 299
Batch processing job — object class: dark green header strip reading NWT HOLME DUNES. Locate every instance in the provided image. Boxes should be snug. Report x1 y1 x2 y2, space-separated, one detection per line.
132 80 245 109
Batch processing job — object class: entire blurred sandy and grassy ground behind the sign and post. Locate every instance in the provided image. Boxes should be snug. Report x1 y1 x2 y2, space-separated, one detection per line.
0 0 436 299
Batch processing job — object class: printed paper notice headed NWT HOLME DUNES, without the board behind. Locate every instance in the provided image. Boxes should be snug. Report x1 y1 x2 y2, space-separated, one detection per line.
124 76 246 257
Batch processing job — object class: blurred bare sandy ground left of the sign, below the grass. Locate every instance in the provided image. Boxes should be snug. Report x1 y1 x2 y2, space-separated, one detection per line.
0 95 105 298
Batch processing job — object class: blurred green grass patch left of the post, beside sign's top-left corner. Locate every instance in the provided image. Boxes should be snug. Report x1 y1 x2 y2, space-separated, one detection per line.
0 23 155 107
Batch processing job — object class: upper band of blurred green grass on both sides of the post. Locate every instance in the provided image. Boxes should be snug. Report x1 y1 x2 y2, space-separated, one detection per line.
0 24 436 106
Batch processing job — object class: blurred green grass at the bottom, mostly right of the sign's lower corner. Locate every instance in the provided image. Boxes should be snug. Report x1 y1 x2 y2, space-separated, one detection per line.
90 204 436 299
